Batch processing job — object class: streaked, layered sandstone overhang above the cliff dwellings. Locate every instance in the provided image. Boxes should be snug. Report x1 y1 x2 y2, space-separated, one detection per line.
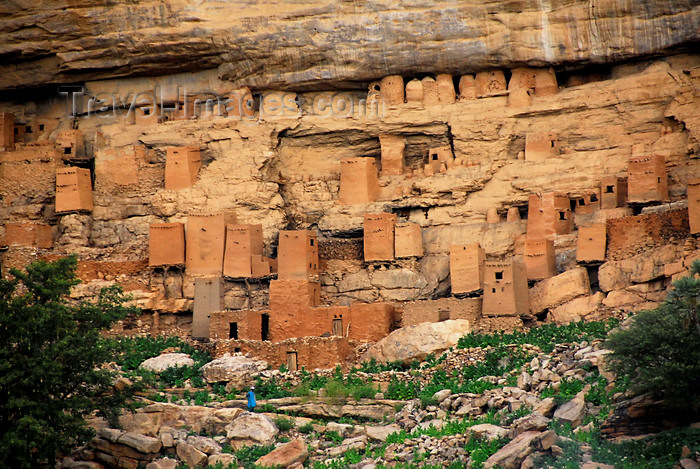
0 0 700 90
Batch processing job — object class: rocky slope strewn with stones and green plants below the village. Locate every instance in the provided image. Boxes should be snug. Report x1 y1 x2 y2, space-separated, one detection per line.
57 318 700 469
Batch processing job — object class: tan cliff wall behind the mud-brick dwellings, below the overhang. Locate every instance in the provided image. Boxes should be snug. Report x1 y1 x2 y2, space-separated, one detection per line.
0 55 700 318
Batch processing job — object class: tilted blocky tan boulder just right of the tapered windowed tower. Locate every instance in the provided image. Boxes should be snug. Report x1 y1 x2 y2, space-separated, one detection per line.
530 267 591 314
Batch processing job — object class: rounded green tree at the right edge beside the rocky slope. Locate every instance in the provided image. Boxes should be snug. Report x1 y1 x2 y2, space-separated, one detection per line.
607 260 700 409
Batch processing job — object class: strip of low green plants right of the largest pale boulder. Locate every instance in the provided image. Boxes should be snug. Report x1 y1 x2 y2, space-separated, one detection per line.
457 318 618 353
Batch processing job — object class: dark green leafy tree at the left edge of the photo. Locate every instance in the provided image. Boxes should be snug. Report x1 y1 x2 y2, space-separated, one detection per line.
0 257 134 468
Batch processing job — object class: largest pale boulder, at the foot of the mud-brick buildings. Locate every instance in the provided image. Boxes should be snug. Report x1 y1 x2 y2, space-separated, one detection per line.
363 319 471 362
